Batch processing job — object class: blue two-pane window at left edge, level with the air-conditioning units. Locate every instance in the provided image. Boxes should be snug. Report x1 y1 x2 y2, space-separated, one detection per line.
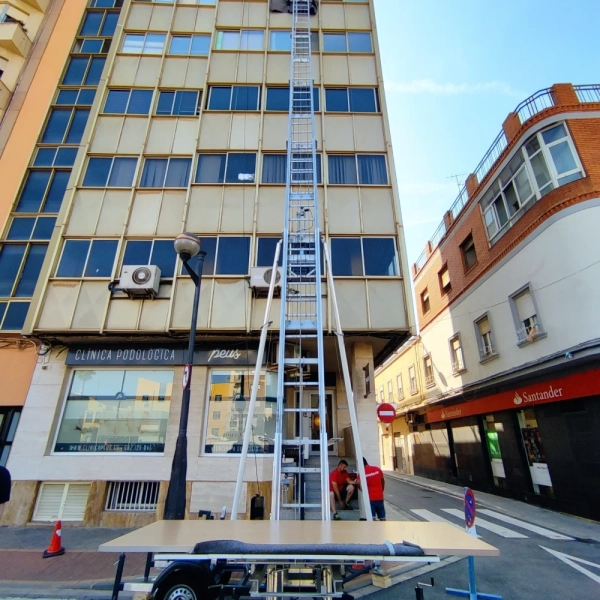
0 244 48 298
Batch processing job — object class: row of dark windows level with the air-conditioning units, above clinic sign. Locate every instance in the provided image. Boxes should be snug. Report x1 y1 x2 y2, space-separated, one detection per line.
50 236 399 280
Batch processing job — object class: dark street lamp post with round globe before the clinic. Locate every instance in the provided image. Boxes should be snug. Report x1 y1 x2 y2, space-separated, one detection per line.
163 233 206 520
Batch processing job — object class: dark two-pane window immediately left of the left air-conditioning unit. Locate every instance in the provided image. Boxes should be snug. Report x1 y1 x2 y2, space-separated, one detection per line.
56 240 118 277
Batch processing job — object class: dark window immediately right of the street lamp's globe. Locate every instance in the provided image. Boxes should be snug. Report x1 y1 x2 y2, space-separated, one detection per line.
183 236 248 276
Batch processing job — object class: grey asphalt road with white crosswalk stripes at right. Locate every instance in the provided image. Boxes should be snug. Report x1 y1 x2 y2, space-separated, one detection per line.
366 477 600 600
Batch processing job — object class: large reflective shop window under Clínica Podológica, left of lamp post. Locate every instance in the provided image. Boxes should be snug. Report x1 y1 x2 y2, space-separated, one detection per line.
54 369 173 454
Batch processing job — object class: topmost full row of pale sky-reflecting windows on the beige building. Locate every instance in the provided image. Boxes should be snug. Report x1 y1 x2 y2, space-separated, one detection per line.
119 29 373 56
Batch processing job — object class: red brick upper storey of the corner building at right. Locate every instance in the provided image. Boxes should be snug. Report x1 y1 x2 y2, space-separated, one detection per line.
413 84 600 329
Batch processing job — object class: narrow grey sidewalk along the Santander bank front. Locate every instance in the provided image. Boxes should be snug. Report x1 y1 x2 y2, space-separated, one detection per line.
384 471 600 542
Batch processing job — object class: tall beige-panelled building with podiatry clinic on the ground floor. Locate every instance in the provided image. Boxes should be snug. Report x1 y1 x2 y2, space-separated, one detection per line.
0 0 413 525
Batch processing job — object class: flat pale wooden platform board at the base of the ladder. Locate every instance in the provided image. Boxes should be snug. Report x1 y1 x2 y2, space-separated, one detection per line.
99 521 500 556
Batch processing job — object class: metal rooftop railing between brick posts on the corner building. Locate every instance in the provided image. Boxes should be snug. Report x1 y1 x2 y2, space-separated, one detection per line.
415 84 600 274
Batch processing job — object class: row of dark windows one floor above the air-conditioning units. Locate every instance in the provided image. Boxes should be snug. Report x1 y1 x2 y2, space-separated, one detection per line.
75 152 388 188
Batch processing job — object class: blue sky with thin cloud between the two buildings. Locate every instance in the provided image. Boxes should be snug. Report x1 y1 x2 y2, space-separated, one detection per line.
374 0 600 264
